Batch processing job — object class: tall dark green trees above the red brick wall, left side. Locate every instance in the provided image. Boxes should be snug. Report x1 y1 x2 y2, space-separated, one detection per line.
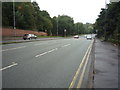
2 2 53 34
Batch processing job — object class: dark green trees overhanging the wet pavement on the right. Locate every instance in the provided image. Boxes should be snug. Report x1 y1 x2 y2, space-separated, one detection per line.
95 2 120 41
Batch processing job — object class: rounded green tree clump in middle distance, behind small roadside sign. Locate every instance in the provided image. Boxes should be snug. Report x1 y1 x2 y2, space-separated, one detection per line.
52 15 74 36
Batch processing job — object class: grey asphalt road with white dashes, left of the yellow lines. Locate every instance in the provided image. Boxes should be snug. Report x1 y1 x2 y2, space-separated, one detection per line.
0 38 93 88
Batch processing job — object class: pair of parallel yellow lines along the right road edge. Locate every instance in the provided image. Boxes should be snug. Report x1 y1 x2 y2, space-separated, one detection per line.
69 40 94 89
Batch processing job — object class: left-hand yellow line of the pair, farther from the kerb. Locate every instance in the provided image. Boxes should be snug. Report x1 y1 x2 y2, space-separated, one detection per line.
69 42 93 88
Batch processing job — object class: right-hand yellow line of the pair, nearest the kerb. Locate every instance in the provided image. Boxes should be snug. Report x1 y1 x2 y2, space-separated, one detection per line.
77 45 91 88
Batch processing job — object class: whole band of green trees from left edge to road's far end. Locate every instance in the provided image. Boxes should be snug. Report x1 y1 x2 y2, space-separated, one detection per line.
2 1 94 36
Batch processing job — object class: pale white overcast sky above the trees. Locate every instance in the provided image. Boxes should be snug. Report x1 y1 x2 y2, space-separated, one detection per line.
32 0 109 23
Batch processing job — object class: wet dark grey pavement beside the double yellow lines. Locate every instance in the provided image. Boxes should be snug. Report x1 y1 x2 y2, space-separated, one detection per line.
94 39 120 88
